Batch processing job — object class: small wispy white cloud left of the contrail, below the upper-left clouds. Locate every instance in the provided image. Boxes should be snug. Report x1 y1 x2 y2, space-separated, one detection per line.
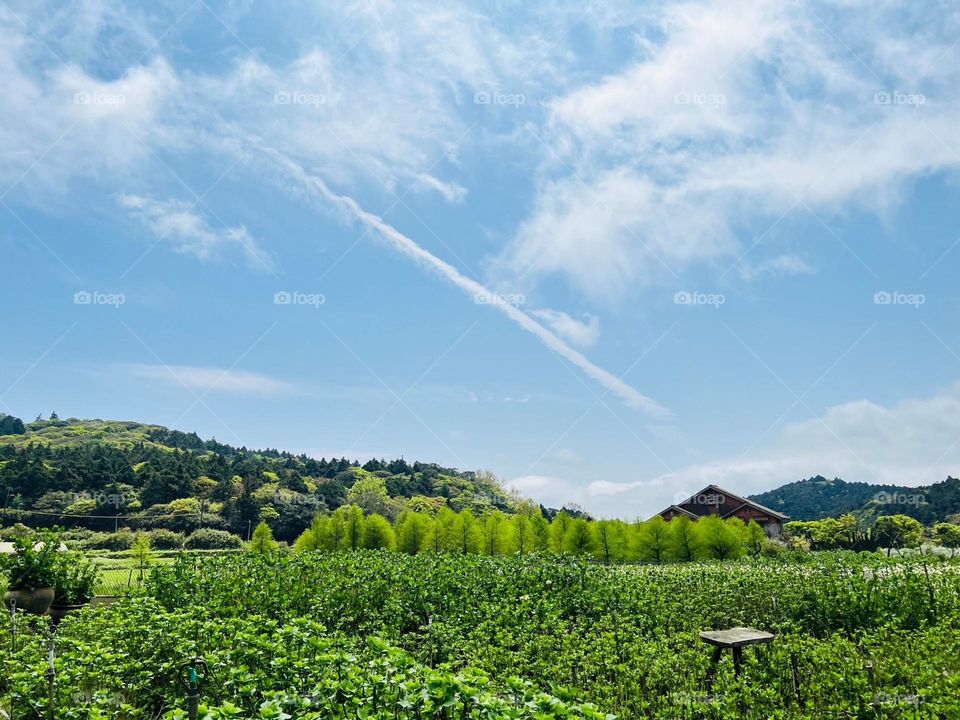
118 195 274 273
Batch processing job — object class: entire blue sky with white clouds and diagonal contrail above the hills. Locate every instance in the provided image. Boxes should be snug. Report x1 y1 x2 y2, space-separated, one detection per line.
0 0 960 517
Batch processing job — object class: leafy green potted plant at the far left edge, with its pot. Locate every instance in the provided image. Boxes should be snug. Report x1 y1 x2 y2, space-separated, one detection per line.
0 532 60 615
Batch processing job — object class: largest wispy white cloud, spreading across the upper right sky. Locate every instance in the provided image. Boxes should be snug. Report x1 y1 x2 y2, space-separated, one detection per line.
498 0 960 301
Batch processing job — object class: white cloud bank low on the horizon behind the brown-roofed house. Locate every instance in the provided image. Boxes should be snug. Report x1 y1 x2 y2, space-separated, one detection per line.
507 382 960 517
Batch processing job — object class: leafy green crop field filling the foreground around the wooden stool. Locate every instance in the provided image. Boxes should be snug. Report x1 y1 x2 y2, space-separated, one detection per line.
0 551 960 720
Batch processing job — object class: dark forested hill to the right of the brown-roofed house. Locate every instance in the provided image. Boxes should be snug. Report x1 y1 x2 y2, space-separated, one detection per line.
750 475 960 525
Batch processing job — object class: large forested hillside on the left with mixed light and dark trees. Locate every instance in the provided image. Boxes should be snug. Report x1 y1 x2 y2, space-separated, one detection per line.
0 415 515 539
